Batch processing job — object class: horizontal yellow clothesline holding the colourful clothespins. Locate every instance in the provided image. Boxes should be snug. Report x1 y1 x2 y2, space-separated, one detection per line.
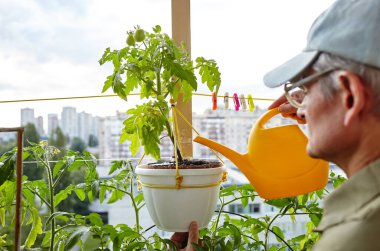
0 92 275 104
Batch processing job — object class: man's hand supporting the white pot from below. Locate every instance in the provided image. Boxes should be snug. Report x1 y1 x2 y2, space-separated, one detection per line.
170 221 199 251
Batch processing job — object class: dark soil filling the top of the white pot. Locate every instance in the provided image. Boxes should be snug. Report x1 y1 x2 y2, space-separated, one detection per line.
145 159 223 169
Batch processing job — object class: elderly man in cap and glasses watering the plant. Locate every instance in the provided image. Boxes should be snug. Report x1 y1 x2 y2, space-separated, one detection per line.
173 0 380 251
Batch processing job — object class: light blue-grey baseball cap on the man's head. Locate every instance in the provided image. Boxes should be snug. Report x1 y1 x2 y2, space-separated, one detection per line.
264 0 380 87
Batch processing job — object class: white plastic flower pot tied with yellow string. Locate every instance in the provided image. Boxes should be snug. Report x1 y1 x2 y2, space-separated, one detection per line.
136 165 225 232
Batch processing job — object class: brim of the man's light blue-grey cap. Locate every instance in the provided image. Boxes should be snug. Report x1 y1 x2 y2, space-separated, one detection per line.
264 51 319 88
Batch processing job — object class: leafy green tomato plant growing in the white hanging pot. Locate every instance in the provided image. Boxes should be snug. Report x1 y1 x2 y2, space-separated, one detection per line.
99 25 221 159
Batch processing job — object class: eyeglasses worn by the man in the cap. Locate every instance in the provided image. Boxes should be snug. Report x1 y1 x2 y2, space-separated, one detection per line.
284 68 337 109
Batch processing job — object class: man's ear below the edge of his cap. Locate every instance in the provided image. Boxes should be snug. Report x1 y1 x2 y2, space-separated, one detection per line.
339 71 366 126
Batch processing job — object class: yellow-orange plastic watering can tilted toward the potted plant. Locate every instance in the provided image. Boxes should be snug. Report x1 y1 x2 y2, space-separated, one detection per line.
194 109 329 199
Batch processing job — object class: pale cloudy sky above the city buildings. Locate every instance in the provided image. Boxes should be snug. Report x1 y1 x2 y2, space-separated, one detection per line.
0 0 333 127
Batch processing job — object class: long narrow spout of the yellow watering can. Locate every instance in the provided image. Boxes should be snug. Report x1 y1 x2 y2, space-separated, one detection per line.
194 136 251 172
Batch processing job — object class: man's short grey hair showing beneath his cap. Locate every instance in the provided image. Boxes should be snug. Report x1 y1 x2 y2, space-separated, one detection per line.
313 52 380 116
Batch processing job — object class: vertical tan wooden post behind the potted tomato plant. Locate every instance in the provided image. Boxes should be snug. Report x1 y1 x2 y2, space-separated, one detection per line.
172 0 193 158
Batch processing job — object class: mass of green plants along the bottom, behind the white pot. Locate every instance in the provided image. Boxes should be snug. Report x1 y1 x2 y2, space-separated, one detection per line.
0 142 345 251
